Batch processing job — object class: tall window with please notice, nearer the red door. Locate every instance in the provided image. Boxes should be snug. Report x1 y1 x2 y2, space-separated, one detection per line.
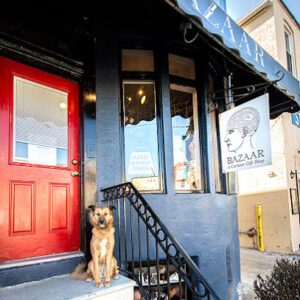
123 81 161 191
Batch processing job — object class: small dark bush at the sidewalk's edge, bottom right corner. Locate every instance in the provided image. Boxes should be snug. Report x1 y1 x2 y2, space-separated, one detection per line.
254 258 300 300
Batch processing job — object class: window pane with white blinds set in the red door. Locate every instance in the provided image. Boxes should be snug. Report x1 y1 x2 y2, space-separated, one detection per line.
13 77 68 166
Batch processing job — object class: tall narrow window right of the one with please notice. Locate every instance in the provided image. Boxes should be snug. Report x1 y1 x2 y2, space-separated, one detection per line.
170 84 202 192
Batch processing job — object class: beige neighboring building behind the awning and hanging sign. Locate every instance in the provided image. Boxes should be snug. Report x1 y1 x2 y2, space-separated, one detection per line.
237 0 300 253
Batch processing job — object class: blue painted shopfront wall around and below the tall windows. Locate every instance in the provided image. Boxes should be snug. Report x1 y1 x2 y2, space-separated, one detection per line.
96 31 240 300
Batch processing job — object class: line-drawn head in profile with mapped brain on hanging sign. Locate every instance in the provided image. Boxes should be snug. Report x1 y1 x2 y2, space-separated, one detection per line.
224 107 260 152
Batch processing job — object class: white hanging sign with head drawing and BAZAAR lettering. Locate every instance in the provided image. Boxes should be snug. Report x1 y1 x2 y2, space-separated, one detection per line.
219 94 272 173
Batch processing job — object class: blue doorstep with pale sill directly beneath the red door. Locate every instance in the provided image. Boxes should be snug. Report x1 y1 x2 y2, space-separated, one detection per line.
0 251 83 288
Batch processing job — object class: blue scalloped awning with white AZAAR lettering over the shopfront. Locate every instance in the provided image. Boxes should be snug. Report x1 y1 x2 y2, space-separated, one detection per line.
164 0 300 117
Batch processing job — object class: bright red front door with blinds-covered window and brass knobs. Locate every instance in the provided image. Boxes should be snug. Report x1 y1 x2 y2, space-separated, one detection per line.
0 57 79 261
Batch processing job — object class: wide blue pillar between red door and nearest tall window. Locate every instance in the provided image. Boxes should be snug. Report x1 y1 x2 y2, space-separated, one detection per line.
96 26 121 201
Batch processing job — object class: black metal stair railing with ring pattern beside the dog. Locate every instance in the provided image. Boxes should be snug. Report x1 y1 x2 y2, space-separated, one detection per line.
101 182 220 300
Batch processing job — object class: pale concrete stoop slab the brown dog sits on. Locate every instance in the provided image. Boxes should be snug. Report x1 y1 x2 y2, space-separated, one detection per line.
0 275 135 300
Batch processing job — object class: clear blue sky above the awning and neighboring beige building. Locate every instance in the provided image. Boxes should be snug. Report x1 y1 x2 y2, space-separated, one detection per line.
226 0 300 24
